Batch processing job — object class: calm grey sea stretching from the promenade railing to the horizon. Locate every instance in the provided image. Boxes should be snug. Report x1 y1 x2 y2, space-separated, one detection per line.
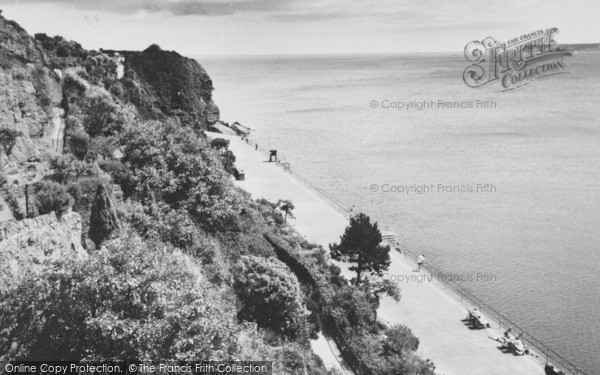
200 53 600 374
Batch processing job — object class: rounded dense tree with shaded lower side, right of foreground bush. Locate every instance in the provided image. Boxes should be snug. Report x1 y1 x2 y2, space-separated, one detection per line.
234 256 305 338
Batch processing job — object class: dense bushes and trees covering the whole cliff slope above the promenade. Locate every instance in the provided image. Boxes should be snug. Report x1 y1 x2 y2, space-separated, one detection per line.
0 15 433 375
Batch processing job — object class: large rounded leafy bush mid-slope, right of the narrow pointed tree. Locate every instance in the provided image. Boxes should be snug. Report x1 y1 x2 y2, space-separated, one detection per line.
120 121 241 232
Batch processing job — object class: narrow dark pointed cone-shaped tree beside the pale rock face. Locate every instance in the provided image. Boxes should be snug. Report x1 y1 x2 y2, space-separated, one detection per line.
89 184 119 248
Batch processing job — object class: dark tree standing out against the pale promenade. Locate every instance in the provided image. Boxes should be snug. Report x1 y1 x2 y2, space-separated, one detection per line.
329 213 390 285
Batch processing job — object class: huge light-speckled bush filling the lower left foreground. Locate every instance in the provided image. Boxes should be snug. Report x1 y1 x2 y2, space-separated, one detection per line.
0 236 239 361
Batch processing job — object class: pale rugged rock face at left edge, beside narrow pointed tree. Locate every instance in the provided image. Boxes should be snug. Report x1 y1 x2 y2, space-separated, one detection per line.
0 212 87 289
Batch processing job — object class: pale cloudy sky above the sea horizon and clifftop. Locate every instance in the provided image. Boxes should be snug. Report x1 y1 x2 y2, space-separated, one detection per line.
0 0 600 56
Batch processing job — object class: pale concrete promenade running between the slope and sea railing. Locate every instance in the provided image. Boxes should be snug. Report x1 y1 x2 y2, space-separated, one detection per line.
207 133 544 375
